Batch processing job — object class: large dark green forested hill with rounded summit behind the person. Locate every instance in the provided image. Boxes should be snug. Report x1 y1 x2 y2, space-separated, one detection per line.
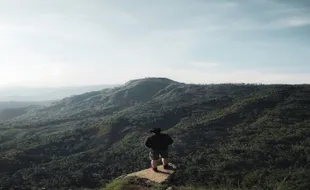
0 78 310 189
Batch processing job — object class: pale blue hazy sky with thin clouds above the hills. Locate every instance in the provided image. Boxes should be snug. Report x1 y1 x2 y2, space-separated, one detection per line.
0 0 310 86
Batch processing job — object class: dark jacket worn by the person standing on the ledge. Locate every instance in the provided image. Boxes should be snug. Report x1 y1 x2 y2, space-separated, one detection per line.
145 133 173 150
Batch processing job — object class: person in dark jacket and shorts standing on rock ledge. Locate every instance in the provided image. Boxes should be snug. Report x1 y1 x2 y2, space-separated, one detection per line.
145 128 173 172
